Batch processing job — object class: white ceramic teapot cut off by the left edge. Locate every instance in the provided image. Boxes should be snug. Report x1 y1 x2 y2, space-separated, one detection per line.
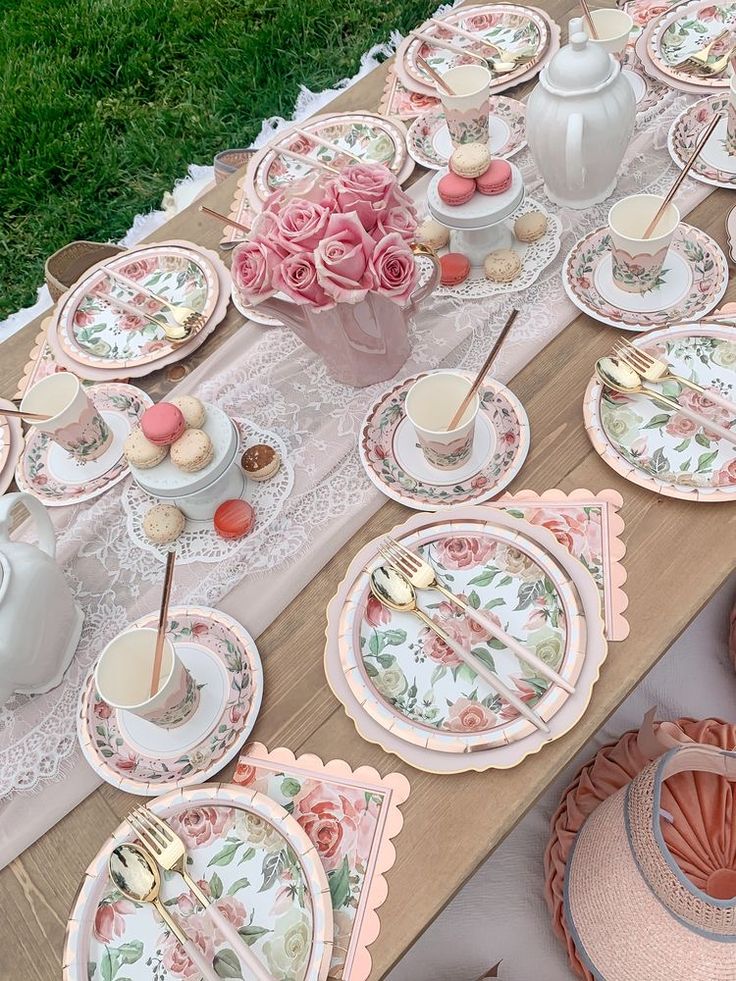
0 494 84 707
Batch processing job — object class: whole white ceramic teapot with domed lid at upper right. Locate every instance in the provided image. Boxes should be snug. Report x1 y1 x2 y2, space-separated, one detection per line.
526 18 636 208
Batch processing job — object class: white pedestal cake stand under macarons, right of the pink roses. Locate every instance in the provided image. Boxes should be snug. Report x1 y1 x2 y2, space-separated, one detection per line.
427 163 524 266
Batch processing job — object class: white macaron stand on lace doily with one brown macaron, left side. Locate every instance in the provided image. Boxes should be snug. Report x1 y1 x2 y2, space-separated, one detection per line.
123 395 293 562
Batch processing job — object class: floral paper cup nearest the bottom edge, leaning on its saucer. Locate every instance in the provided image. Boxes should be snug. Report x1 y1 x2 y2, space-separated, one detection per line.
95 627 199 729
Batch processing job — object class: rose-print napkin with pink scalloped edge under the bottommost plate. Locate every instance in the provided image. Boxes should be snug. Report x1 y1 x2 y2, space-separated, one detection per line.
233 743 410 981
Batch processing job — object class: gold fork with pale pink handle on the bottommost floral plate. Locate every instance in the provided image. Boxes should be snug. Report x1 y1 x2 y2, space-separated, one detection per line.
127 807 275 981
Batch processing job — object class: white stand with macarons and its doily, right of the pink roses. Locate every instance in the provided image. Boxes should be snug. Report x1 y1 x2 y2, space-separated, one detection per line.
417 143 562 299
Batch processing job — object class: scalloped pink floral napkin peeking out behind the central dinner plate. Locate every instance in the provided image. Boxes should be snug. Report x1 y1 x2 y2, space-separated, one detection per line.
485 488 629 640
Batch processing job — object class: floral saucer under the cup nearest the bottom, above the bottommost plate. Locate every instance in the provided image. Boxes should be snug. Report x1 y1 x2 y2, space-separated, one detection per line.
77 606 263 797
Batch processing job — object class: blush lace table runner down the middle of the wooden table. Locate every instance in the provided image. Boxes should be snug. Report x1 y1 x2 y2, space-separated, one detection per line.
0 96 710 867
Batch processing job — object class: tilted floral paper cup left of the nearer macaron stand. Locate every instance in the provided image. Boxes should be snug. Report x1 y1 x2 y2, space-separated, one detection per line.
20 371 113 463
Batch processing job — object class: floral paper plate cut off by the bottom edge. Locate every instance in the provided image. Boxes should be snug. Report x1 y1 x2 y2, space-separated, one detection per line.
62 784 333 981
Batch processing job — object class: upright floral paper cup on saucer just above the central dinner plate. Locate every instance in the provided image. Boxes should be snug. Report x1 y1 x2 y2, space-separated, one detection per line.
404 371 480 470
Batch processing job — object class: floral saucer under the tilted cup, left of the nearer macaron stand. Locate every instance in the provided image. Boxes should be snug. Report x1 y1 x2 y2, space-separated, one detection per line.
15 382 152 508
